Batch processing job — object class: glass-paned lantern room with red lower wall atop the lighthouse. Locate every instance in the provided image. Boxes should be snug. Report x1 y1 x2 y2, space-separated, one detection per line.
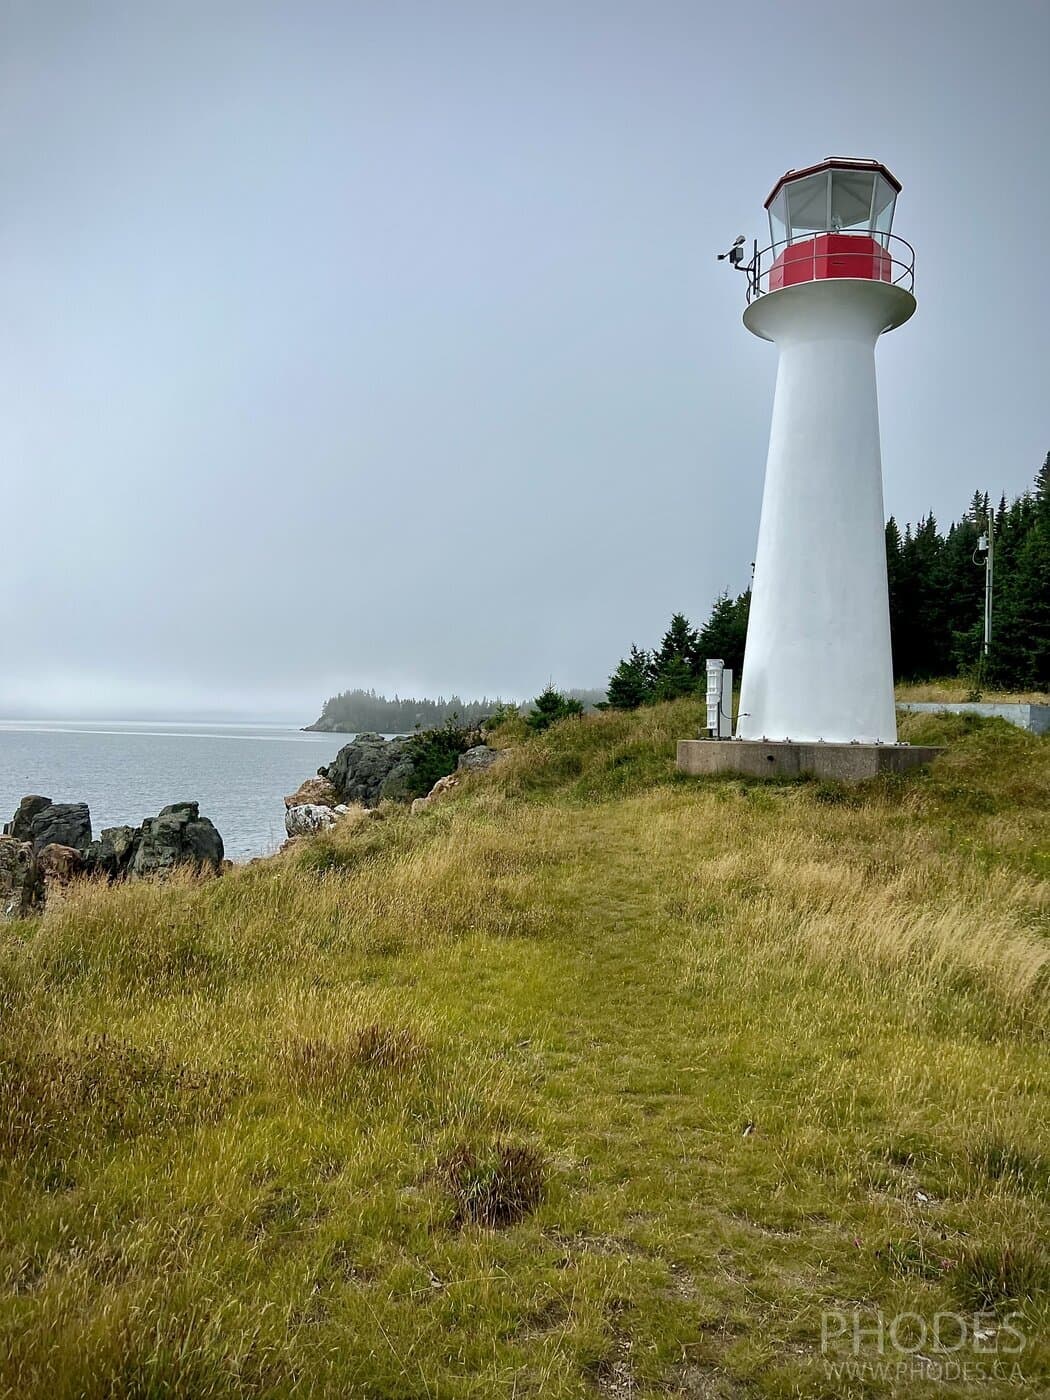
766 155 900 291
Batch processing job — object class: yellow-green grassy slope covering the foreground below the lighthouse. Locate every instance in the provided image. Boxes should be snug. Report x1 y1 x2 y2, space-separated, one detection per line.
0 701 1050 1400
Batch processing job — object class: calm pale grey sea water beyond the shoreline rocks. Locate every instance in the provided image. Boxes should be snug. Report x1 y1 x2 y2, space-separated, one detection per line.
0 720 353 861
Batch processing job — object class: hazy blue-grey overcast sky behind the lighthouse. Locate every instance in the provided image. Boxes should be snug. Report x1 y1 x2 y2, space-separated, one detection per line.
0 0 1050 722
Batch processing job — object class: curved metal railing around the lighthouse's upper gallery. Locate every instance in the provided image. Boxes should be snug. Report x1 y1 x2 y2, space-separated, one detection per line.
741 228 916 305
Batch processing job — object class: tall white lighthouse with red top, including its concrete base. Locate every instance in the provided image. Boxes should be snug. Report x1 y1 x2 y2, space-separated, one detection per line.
678 157 934 780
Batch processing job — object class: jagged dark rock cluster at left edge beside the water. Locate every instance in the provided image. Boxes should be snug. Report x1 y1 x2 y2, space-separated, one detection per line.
0 794 228 918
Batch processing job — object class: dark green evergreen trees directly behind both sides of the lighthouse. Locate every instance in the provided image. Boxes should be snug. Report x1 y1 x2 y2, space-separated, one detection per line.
608 454 1050 710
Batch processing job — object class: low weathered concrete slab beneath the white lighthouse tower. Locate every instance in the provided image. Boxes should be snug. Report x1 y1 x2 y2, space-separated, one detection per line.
678 739 944 783
